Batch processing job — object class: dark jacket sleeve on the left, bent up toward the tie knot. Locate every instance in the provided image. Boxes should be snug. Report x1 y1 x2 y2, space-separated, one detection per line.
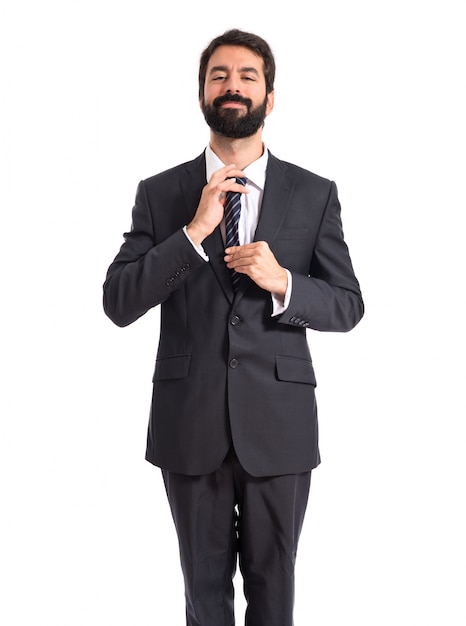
103 181 205 326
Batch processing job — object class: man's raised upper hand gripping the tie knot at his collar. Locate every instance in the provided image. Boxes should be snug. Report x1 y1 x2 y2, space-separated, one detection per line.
186 164 249 245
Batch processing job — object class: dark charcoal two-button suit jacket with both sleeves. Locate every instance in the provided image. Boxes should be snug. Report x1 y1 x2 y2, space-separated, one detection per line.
104 149 363 476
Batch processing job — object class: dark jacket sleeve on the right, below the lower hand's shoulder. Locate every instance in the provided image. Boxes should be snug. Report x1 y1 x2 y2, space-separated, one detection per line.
279 182 364 332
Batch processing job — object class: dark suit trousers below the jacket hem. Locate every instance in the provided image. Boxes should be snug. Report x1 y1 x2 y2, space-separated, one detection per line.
162 449 311 626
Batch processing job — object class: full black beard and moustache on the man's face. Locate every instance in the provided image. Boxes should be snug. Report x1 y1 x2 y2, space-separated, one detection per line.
202 94 267 139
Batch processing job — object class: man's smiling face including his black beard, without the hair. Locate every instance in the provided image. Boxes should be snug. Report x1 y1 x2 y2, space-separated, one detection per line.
200 46 273 138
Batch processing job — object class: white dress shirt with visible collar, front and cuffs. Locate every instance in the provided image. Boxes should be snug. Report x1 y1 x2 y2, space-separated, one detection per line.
184 145 292 316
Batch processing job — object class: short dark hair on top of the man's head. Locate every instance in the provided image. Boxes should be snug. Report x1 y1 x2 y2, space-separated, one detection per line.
199 28 275 100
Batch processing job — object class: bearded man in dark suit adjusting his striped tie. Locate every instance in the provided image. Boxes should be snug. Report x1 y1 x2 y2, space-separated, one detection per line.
104 30 363 626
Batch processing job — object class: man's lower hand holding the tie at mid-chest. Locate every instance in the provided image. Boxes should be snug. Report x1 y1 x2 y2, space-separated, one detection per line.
224 241 288 298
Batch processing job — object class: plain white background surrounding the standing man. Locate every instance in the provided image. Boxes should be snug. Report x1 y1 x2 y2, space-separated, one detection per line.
0 0 466 626
